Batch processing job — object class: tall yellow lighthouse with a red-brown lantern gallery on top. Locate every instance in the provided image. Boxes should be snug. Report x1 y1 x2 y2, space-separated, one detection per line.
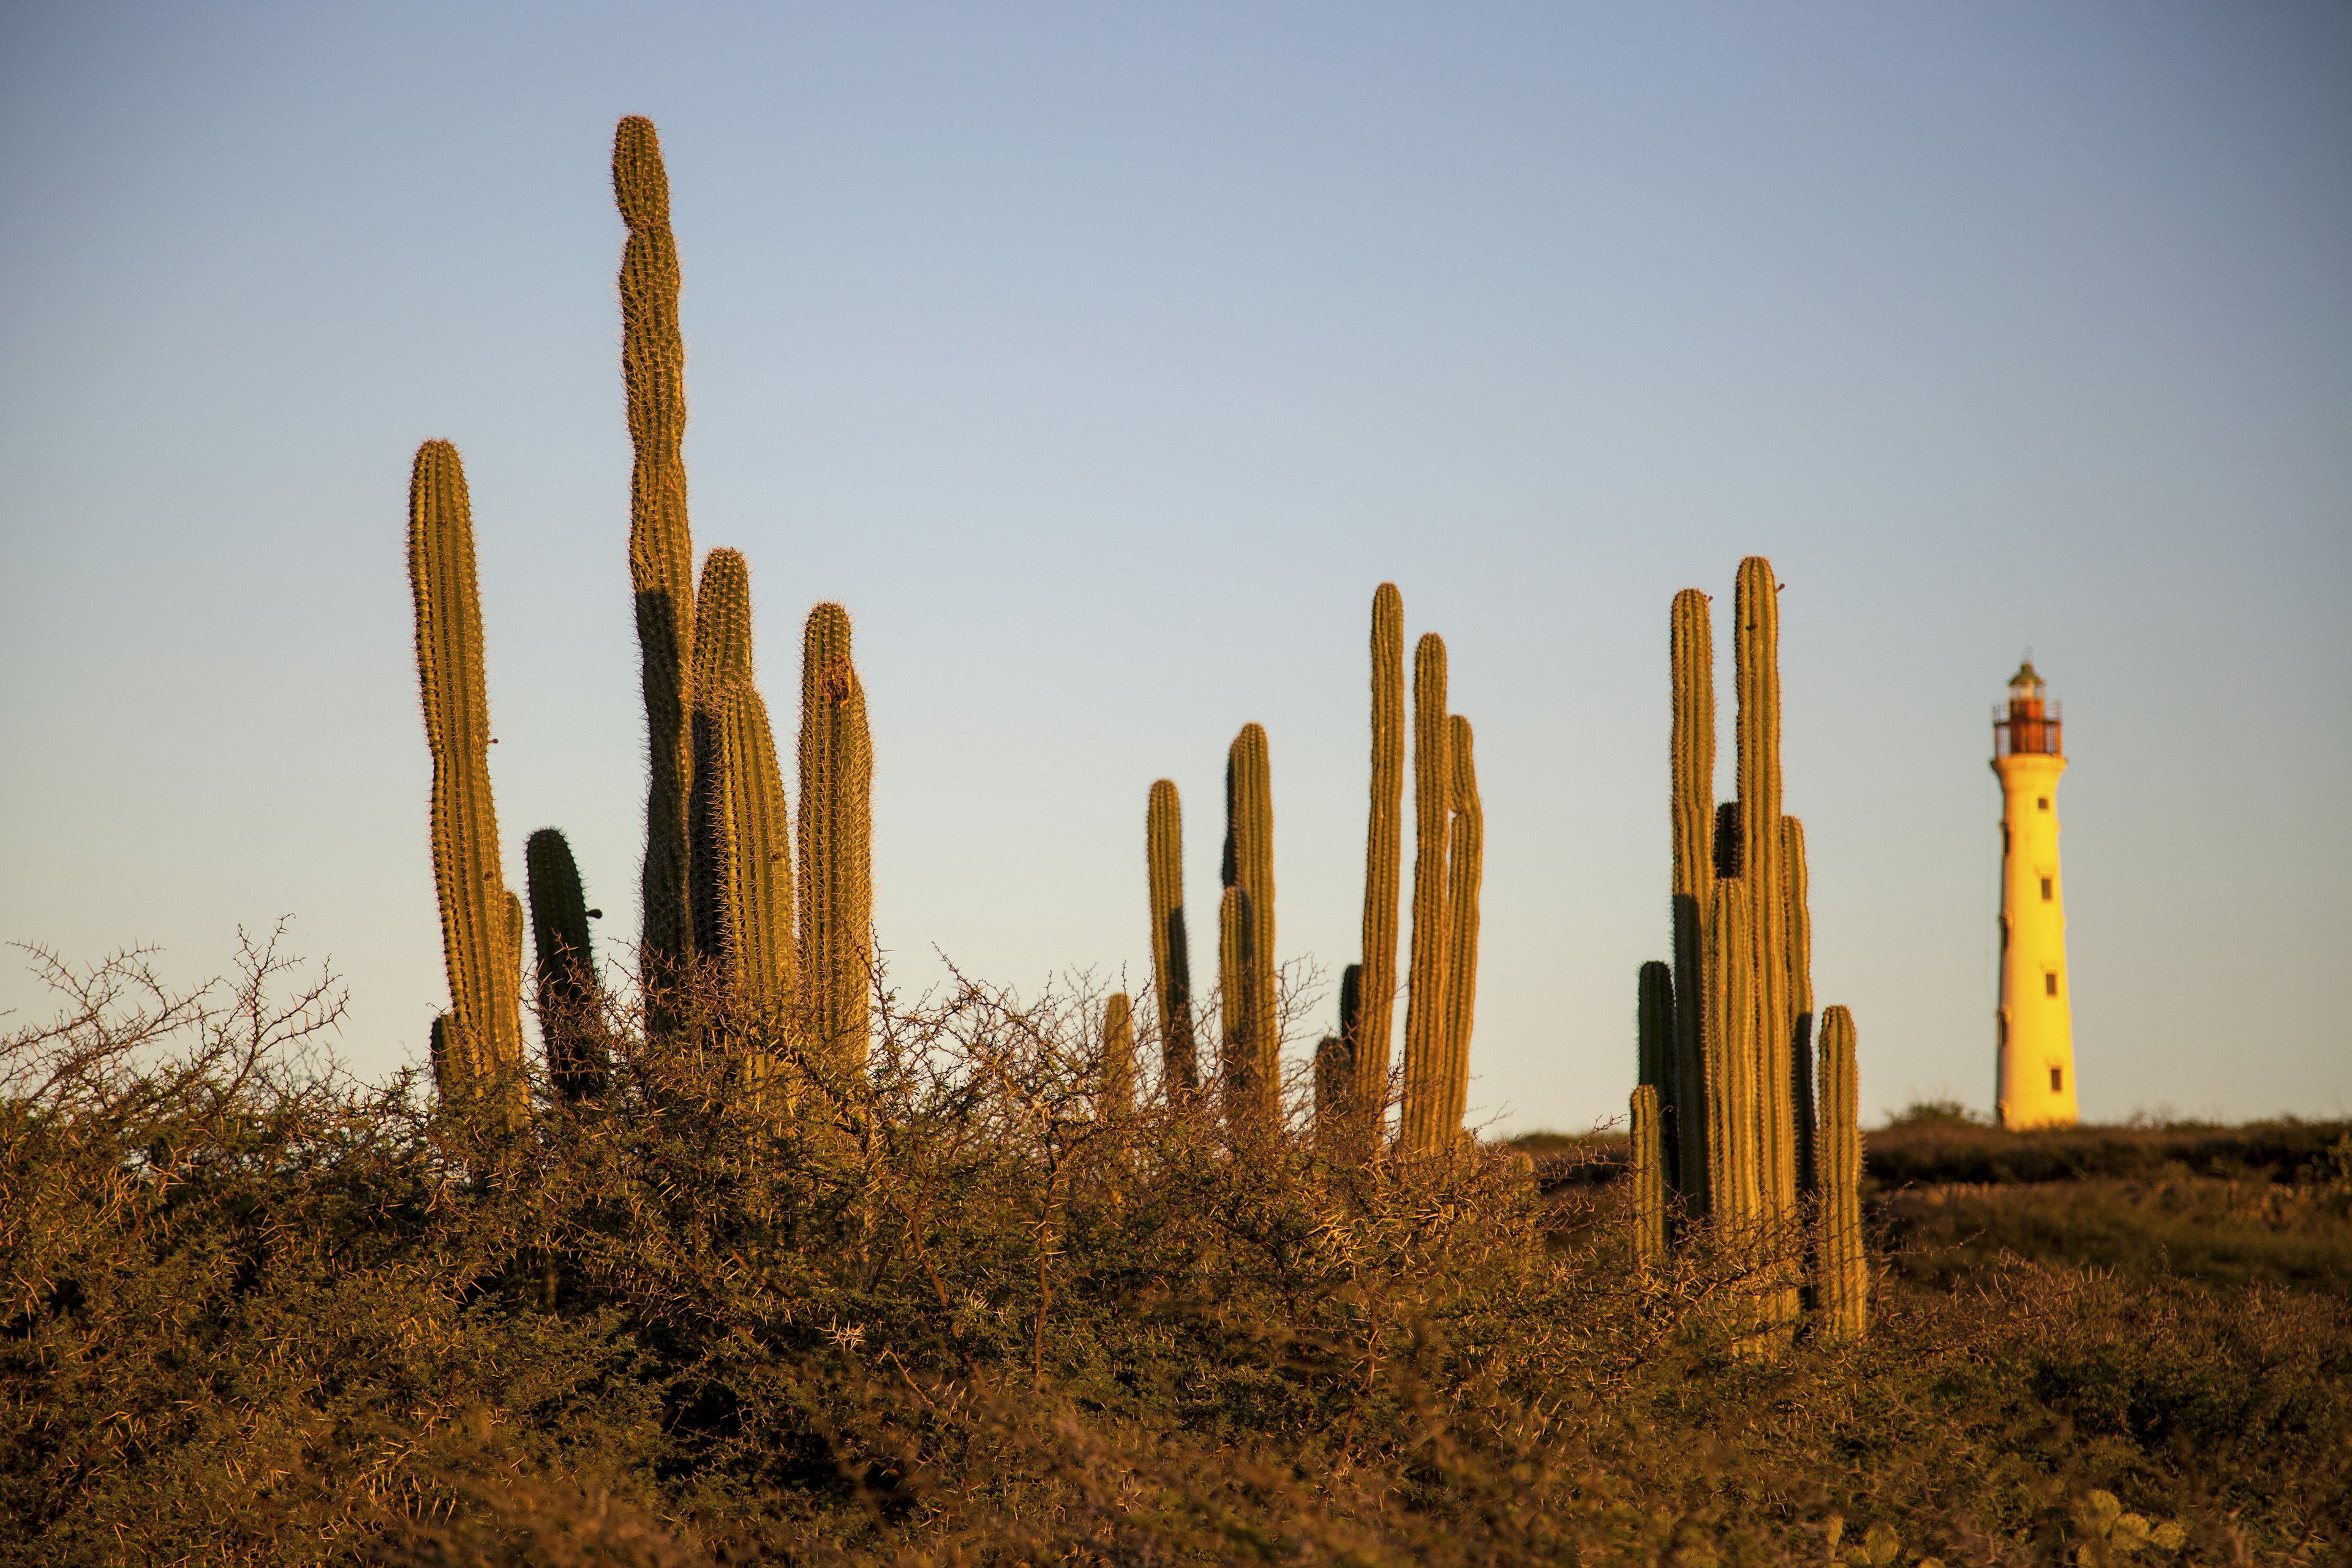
1992 658 2077 1128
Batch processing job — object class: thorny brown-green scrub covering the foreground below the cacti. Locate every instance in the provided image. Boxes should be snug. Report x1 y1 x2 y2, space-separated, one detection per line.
0 943 2352 1563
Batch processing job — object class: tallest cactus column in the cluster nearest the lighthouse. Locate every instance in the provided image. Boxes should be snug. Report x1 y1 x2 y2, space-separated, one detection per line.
1733 555 1797 1215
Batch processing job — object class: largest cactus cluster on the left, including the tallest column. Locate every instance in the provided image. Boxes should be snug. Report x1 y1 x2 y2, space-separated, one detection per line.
409 118 873 1117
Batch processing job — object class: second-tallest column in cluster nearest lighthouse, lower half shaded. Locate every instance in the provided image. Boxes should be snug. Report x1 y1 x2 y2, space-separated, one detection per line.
1660 588 1714 1215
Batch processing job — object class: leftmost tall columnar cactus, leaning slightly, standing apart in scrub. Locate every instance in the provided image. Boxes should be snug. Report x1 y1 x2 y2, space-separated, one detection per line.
409 442 522 1110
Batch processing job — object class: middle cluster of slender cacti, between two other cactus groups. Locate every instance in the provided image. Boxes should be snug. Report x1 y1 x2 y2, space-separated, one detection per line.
1145 583 1484 1159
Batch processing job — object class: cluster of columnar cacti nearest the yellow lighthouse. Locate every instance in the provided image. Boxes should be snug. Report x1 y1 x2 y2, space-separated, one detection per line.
1632 555 1868 1335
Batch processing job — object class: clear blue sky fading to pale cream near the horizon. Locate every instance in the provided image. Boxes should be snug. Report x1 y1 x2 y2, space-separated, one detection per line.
0 2 2352 1133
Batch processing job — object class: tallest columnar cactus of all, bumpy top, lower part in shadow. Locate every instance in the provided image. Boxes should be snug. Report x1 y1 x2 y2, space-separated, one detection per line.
611 115 694 971
